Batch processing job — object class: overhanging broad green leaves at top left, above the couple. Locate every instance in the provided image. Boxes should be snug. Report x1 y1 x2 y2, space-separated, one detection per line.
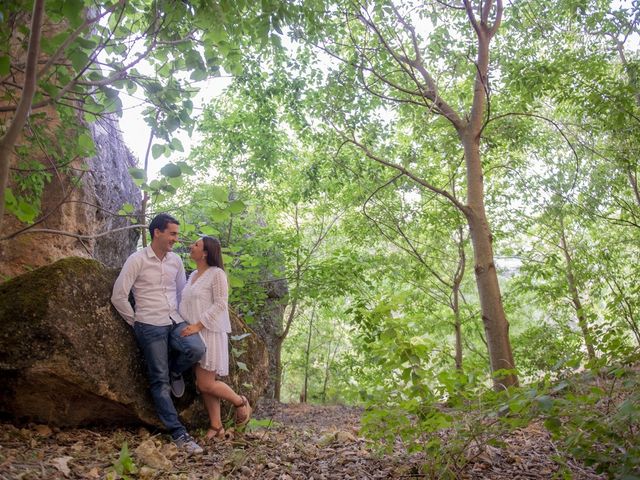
0 0 310 229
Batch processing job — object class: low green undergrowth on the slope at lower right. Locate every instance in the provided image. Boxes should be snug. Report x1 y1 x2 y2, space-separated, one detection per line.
362 363 640 480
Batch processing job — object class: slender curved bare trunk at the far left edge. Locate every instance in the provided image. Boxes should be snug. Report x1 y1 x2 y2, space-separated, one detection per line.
0 0 44 229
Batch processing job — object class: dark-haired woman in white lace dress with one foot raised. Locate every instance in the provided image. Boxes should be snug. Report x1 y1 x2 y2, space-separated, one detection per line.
179 237 251 440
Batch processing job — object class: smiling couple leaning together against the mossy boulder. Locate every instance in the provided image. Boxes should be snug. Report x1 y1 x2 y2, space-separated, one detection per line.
111 213 251 453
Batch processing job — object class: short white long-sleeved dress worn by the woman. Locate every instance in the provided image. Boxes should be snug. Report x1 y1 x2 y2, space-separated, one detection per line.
179 267 231 377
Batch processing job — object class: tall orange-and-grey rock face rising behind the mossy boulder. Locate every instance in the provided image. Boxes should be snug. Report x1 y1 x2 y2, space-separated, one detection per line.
0 6 142 278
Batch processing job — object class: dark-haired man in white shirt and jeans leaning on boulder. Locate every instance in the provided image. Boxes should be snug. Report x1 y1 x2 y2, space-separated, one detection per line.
111 213 205 454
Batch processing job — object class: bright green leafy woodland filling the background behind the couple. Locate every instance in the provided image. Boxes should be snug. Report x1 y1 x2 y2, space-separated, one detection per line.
0 0 640 479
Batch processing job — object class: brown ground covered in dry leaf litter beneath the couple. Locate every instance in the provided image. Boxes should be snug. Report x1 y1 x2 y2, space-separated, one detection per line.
0 401 605 480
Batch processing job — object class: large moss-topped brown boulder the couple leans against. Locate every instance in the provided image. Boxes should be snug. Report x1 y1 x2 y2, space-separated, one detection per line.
0 257 267 426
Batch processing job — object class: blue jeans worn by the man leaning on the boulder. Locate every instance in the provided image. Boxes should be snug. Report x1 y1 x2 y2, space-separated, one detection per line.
133 322 205 440
